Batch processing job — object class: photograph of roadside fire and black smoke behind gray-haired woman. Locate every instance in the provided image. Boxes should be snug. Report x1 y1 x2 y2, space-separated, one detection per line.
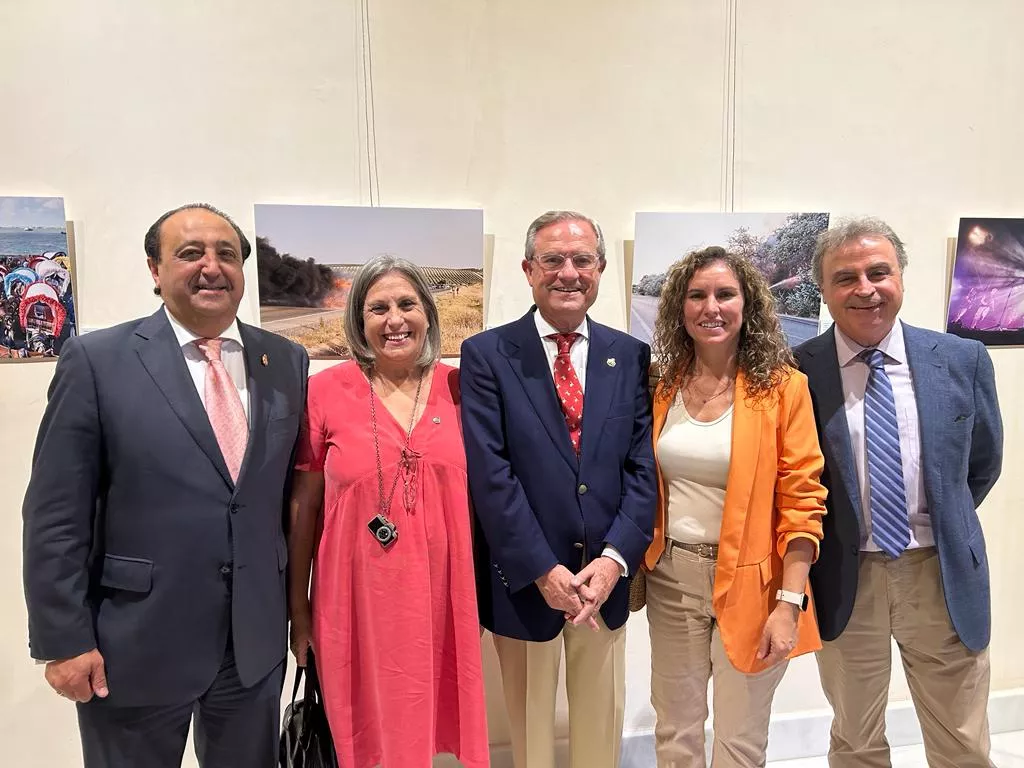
255 205 483 359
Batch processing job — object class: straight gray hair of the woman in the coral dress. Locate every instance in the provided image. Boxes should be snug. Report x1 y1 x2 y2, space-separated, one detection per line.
345 255 441 369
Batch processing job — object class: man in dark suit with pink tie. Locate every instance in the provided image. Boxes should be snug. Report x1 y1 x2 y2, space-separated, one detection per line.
24 204 308 768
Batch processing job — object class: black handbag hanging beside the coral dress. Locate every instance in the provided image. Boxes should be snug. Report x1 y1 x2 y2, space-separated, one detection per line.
278 648 339 768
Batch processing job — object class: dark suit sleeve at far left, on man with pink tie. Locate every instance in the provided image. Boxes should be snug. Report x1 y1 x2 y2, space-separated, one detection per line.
22 340 103 659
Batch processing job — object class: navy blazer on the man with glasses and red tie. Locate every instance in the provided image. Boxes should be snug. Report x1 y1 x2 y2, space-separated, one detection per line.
460 308 656 641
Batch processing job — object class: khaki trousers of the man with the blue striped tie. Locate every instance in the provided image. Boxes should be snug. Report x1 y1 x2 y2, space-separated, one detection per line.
818 547 992 768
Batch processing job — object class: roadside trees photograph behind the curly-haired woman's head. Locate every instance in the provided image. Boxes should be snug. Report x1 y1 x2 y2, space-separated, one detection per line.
630 213 828 346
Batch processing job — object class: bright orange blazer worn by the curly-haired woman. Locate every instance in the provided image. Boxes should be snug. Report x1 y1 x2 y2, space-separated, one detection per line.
644 370 827 673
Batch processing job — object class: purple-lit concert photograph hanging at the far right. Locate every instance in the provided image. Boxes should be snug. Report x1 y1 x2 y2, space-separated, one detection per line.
946 218 1024 347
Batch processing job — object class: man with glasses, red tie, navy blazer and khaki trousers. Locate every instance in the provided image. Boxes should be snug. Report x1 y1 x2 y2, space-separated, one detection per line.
461 211 656 768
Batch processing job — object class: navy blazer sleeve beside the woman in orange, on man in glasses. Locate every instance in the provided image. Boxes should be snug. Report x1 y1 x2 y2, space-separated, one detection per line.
604 344 657 573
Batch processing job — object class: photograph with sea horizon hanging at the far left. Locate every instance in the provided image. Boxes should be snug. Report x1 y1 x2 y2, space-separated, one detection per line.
0 197 77 361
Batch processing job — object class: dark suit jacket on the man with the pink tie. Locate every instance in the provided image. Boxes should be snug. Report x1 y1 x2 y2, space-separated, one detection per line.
23 308 308 706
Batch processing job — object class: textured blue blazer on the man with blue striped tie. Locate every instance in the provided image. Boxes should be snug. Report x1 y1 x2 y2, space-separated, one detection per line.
795 323 1002 651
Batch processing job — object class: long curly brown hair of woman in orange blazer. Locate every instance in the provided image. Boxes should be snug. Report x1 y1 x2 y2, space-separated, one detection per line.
653 246 793 399
